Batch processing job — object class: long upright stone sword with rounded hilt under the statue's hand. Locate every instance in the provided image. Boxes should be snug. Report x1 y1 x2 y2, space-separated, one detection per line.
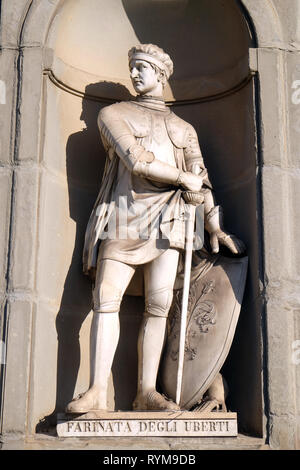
176 185 204 405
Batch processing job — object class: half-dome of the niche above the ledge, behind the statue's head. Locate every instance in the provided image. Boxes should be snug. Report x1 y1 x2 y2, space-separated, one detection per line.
42 0 250 101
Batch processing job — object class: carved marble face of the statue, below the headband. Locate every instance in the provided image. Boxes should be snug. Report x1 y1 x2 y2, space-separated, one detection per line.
130 60 161 95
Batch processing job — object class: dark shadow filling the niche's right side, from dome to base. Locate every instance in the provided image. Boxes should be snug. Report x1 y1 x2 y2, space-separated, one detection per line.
122 0 262 435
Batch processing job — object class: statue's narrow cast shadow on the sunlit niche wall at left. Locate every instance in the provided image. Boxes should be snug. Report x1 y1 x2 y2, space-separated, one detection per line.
36 82 132 433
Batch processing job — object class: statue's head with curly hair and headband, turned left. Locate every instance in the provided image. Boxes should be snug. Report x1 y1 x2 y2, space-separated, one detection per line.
128 44 173 95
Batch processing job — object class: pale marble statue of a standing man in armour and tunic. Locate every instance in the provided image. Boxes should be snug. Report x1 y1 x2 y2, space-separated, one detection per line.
66 44 243 413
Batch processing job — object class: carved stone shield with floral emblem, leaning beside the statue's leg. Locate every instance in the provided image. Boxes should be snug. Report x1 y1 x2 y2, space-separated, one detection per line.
160 256 248 410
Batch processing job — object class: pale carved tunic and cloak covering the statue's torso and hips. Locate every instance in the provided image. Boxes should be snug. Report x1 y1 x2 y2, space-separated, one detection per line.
83 100 215 284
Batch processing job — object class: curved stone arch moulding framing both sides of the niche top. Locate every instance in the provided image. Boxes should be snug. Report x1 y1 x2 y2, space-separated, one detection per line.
7 0 284 47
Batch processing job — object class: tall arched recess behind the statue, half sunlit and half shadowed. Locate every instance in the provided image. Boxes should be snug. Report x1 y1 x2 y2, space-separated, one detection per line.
35 0 262 436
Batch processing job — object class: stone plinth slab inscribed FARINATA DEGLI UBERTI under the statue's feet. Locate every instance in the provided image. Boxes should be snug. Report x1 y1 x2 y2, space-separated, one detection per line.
57 411 237 437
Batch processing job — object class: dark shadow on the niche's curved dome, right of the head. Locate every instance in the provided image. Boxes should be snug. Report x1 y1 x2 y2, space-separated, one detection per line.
122 0 251 99
